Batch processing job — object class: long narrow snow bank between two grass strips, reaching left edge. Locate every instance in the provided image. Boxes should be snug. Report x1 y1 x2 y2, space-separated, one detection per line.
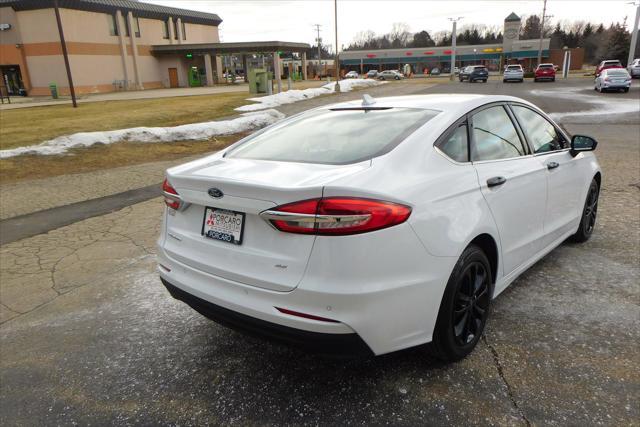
0 110 285 159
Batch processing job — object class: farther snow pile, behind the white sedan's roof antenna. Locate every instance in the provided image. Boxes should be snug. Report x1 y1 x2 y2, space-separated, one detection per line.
236 79 383 111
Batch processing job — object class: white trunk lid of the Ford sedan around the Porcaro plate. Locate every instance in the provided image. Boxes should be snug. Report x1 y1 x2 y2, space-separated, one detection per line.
164 157 371 291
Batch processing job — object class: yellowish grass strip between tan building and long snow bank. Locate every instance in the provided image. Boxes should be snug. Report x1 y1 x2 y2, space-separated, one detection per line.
0 92 249 150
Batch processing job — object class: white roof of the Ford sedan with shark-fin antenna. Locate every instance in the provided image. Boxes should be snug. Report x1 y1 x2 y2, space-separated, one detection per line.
320 93 532 116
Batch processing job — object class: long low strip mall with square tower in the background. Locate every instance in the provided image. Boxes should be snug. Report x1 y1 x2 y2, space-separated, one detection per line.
340 13 583 74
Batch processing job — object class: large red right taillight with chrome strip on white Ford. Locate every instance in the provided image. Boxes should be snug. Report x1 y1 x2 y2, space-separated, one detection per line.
260 197 411 236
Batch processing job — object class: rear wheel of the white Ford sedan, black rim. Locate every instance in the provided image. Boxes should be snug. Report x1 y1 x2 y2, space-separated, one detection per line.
427 245 493 362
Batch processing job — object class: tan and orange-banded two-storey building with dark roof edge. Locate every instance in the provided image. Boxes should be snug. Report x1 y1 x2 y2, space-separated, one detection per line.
0 0 222 96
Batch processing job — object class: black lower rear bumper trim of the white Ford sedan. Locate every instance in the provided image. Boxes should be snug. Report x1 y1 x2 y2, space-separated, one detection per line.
160 278 373 357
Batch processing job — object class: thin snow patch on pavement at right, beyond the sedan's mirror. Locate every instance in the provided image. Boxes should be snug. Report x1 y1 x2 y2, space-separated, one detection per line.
530 86 640 123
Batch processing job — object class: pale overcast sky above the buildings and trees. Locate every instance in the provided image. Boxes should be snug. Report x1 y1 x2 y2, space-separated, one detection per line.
149 0 635 46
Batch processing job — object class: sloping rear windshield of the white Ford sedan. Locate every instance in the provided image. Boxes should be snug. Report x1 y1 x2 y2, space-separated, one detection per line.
225 108 439 164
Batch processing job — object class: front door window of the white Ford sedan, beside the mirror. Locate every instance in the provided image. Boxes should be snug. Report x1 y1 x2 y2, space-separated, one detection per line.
511 105 566 154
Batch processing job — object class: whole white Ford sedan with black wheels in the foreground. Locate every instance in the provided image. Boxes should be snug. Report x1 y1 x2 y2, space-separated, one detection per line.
158 94 602 361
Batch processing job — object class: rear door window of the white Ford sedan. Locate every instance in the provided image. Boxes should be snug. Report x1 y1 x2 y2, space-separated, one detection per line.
471 106 525 161
